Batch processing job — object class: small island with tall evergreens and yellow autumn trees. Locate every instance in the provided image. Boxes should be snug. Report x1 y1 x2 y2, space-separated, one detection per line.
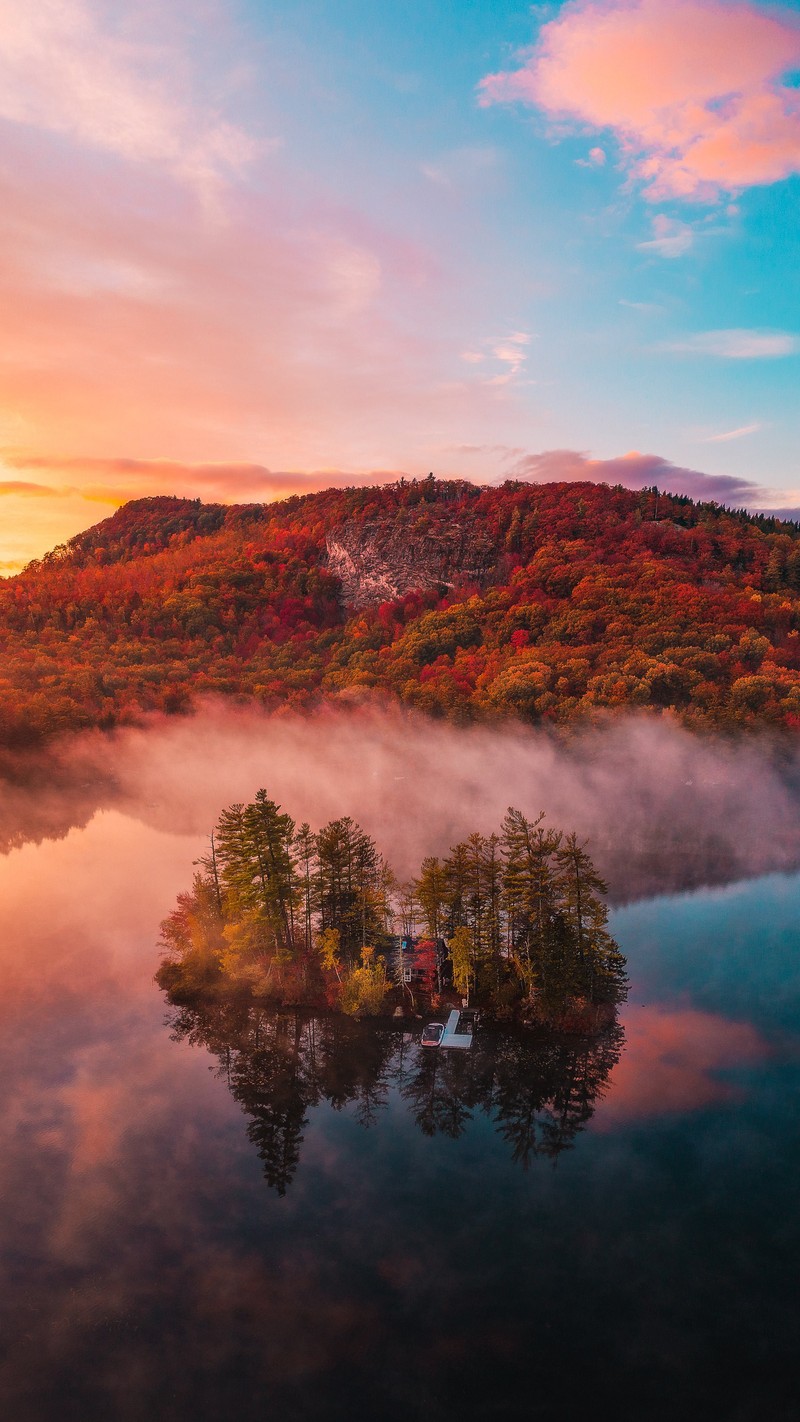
156 789 627 1035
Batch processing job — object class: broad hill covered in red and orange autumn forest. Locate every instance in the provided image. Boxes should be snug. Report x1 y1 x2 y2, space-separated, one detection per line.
0 478 800 747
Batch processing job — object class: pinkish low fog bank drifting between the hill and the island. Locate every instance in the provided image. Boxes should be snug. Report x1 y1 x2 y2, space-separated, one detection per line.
0 702 800 902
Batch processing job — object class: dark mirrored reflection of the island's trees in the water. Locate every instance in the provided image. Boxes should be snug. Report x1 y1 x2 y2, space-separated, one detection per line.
171 1003 624 1194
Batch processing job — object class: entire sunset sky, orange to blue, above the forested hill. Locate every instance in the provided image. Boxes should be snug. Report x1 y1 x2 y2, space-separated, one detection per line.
0 0 800 574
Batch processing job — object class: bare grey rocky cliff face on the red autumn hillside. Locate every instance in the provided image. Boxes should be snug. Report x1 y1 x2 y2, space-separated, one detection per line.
325 512 496 607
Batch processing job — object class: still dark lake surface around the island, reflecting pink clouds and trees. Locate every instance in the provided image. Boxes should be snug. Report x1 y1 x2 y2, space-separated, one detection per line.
0 813 800 1422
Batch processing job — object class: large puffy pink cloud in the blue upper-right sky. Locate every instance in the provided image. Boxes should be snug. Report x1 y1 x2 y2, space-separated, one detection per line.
480 0 800 201
